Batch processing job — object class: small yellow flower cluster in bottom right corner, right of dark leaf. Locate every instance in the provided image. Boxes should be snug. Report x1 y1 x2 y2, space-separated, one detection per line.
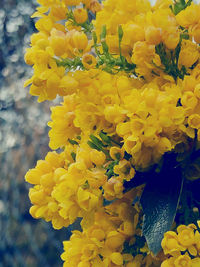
161 224 200 267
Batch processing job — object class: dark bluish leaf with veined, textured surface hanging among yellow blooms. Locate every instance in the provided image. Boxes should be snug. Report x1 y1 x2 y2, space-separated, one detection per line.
140 165 183 255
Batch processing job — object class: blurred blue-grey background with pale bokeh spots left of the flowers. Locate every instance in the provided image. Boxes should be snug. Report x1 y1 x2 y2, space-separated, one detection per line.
0 0 69 267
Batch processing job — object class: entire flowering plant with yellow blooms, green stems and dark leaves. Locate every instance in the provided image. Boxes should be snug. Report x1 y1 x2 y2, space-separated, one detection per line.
25 0 200 267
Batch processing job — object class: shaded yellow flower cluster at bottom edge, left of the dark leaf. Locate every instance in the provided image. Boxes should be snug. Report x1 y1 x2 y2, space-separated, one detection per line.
61 191 159 267
